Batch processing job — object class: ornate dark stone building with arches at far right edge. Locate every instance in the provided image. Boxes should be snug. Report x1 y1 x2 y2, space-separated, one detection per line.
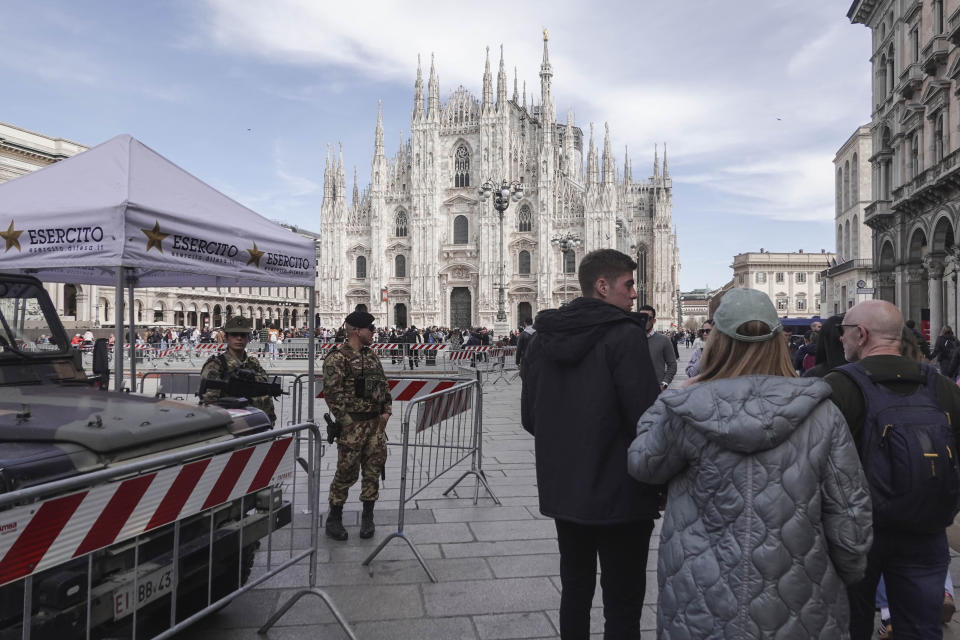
847 0 960 336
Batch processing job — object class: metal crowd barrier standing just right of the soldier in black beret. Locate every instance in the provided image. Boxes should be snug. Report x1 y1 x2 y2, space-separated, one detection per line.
363 380 500 582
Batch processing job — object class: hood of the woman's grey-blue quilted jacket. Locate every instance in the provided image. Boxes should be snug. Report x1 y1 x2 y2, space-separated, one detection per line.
660 376 831 453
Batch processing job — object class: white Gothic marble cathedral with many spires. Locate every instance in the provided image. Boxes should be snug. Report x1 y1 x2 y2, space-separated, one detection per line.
317 32 679 329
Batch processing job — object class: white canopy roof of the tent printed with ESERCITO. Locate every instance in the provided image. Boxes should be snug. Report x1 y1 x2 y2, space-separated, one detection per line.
0 135 316 287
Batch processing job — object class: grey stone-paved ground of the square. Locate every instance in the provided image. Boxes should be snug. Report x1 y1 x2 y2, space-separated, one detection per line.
172 349 960 640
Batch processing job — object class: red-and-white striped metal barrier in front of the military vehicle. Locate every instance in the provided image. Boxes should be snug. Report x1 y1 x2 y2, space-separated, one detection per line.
0 423 356 640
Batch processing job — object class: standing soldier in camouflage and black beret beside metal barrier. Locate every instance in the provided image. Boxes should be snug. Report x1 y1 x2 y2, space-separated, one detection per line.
323 311 393 540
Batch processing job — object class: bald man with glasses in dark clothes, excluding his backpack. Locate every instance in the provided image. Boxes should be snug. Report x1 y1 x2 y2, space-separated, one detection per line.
824 300 960 640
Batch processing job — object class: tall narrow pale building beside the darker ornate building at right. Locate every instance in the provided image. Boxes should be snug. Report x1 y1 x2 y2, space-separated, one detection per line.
821 125 874 315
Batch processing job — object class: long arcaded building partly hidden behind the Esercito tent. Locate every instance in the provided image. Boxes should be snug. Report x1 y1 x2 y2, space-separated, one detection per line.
0 122 317 329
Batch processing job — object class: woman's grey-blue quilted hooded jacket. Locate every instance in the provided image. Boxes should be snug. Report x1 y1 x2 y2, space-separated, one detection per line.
628 376 873 640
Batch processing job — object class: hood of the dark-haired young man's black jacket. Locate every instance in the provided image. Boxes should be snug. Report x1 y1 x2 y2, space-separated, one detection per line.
534 298 646 363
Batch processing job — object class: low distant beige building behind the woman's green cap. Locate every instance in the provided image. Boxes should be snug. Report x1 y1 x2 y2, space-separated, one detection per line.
731 249 836 318
